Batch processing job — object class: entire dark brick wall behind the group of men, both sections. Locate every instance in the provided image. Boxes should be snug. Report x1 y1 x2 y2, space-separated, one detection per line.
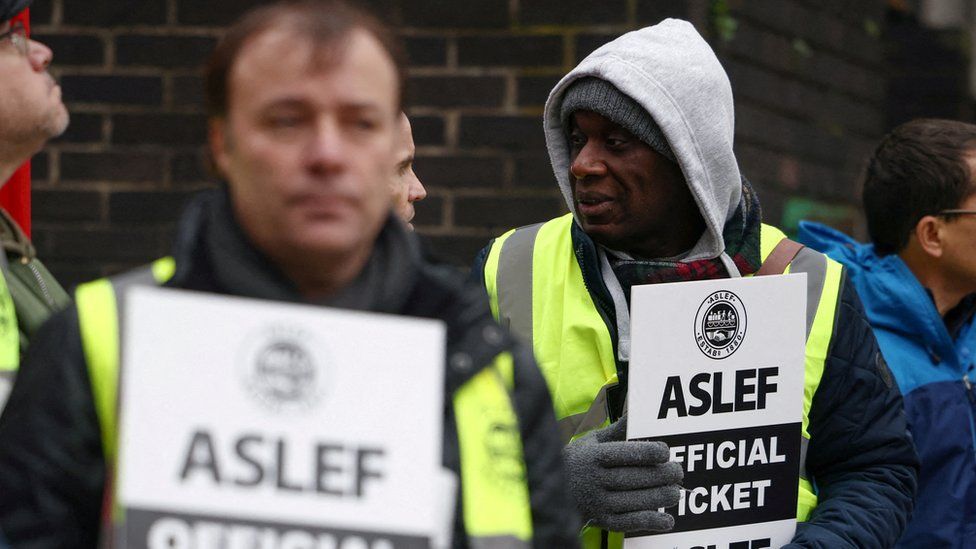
24 0 886 284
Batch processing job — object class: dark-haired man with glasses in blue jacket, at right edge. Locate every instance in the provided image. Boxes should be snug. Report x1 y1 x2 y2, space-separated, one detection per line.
800 120 976 548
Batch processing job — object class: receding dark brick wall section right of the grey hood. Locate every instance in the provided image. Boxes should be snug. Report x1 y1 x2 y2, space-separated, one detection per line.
716 0 887 234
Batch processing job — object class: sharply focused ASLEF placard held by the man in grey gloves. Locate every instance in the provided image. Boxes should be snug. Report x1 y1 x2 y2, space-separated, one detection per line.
625 273 806 549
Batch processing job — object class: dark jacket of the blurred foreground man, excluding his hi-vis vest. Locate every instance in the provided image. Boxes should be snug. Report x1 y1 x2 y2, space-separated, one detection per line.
0 192 579 548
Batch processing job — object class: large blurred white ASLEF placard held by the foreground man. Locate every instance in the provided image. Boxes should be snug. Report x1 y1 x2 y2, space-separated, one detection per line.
116 288 454 549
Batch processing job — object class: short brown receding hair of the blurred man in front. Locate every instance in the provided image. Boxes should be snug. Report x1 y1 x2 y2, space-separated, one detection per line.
204 0 406 118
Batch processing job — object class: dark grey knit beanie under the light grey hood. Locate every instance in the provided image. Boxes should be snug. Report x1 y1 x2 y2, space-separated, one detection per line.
559 76 677 163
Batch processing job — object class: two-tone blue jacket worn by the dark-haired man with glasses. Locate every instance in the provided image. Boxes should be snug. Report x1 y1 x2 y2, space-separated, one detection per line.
799 222 976 549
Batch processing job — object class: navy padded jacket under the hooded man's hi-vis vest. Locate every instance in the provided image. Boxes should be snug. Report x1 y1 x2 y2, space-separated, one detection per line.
471 223 919 549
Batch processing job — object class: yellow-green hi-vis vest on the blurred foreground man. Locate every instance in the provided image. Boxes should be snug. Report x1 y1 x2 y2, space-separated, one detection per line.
75 258 532 549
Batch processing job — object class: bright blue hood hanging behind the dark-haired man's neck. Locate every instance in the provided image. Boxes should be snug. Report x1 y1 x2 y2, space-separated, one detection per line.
797 221 952 344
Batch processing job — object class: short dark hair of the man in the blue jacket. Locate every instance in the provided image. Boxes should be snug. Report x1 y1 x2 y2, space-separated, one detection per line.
862 118 976 255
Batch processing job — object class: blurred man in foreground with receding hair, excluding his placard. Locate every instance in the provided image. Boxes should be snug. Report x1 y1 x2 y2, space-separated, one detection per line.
0 1 575 547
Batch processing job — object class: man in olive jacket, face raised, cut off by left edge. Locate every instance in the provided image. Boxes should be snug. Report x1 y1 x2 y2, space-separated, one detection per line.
0 0 68 416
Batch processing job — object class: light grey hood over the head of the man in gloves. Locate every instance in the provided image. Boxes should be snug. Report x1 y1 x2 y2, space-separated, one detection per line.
544 19 742 260
